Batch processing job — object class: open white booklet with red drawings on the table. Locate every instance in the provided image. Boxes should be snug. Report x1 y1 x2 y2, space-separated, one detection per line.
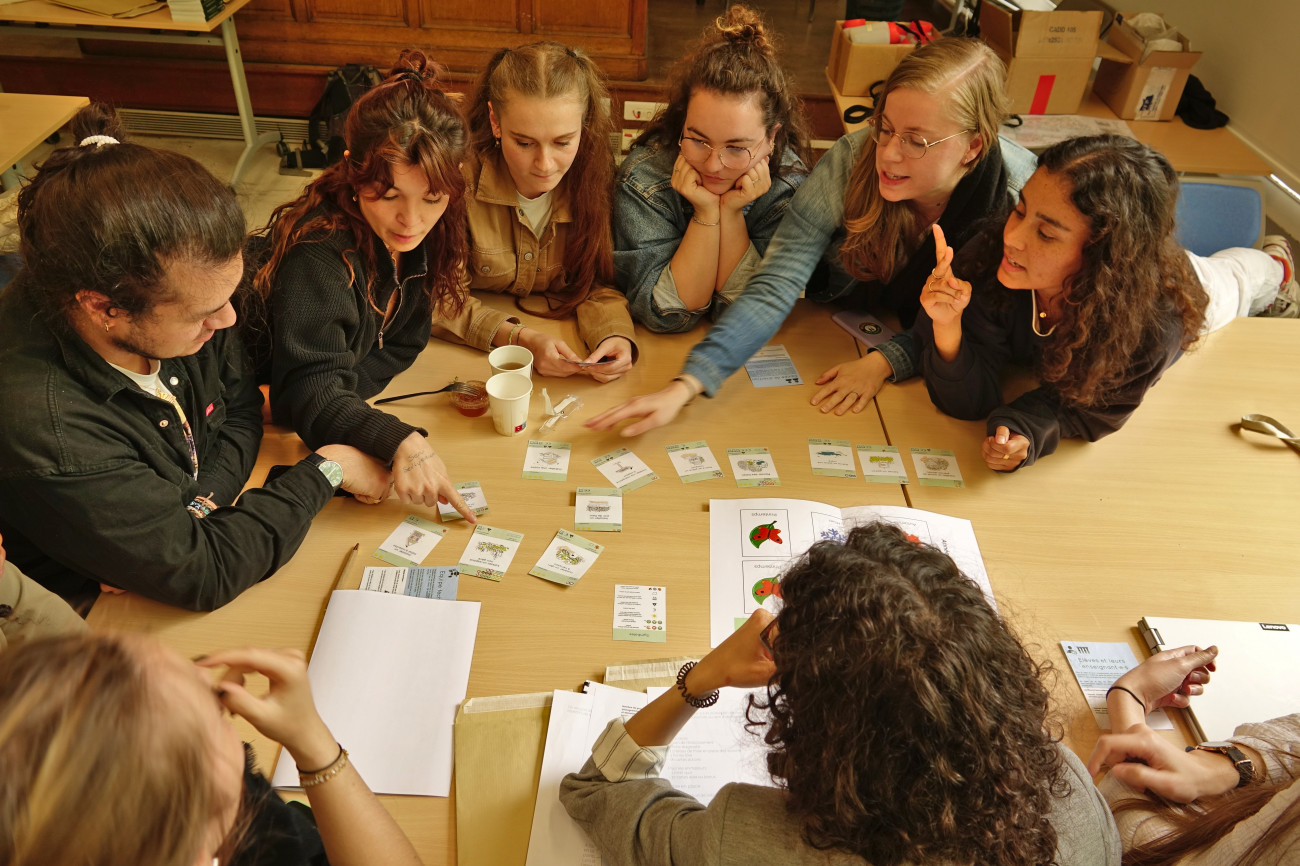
709 499 997 646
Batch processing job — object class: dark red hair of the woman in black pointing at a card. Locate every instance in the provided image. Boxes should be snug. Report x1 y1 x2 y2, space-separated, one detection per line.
254 49 469 316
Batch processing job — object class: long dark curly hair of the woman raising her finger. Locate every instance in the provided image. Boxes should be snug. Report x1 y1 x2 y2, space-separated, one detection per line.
954 135 1209 406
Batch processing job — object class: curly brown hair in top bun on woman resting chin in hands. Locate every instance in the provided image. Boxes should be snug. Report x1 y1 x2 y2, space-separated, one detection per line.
636 5 811 177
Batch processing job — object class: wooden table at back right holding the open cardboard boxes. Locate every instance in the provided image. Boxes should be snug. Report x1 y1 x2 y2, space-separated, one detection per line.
827 75 1273 176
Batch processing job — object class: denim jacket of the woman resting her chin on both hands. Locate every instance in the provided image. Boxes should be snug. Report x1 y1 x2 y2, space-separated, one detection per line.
614 144 807 333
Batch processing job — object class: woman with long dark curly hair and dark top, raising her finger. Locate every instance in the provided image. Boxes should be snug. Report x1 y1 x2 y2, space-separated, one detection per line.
915 135 1206 472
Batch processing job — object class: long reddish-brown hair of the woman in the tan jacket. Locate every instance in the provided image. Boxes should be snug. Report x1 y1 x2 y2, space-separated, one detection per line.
465 42 614 319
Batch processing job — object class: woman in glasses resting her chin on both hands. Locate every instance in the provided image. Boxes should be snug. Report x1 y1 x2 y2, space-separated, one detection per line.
614 7 807 333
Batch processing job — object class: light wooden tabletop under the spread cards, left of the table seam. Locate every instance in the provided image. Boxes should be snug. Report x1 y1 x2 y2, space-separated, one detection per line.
90 298 889 863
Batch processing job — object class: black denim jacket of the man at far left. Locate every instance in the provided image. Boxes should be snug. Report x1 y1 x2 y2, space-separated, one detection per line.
0 273 332 610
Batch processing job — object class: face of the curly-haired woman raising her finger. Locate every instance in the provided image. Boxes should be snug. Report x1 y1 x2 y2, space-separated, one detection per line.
997 168 1092 296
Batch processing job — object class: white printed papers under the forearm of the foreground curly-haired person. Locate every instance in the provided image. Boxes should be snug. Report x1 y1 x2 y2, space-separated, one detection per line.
528 683 772 866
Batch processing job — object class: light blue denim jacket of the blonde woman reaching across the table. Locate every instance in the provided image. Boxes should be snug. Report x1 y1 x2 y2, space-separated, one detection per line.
683 129 1035 395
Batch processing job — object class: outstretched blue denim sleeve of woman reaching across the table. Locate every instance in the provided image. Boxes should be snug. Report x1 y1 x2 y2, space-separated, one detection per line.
683 133 865 397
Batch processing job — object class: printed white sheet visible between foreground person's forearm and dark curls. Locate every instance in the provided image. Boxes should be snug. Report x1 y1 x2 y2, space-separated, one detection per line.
646 687 775 805
